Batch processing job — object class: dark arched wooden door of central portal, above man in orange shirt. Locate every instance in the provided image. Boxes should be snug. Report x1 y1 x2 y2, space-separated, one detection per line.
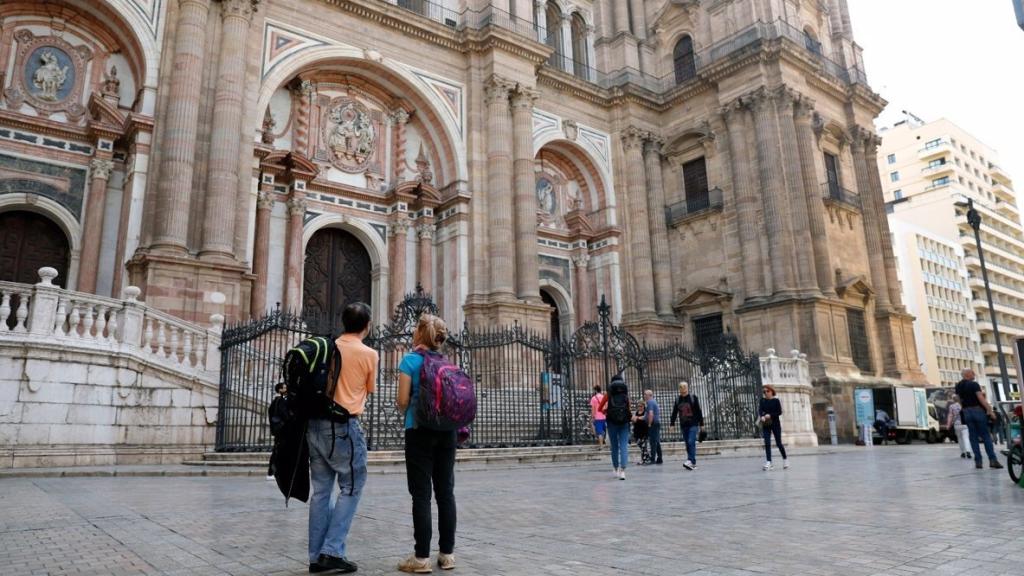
302 228 373 332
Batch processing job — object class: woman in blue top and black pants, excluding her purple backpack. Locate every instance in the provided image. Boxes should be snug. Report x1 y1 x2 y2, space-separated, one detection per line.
397 314 457 574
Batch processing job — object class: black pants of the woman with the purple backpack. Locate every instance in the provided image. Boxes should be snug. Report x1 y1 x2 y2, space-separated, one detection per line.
406 428 456 558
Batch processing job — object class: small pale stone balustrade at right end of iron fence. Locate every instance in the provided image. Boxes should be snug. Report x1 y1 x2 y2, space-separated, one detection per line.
761 348 818 446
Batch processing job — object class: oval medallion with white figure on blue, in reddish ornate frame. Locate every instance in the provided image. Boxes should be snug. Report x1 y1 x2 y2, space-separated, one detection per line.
4 29 92 120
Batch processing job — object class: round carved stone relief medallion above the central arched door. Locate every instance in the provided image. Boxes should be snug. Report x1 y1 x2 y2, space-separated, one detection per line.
323 97 377 172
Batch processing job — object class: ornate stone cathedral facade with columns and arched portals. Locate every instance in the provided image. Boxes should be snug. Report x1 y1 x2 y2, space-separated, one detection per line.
0 0 922 399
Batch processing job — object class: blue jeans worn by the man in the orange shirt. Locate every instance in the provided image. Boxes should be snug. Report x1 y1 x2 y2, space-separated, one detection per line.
306 418 367 564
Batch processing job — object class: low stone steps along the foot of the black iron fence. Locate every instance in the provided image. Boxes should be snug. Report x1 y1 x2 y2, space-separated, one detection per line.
182 439 764 474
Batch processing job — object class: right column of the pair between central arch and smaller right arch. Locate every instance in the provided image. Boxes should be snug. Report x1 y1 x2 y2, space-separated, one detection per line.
512 87 541 301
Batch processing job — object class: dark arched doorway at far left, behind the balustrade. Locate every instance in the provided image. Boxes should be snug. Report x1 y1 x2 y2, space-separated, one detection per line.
0 210 71 287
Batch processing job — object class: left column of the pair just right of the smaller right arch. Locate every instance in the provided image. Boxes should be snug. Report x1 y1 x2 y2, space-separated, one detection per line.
623 127 655 318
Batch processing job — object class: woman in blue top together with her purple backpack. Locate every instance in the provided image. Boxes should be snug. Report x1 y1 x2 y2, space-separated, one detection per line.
396 314 476 574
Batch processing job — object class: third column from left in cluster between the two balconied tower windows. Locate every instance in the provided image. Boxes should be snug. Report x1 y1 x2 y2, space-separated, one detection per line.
775 87 818 293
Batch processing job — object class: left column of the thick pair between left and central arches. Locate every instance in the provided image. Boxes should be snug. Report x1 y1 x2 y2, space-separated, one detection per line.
153 0 210 253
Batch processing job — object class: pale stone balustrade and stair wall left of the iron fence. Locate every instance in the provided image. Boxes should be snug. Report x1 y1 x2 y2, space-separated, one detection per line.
0 268 223 468
